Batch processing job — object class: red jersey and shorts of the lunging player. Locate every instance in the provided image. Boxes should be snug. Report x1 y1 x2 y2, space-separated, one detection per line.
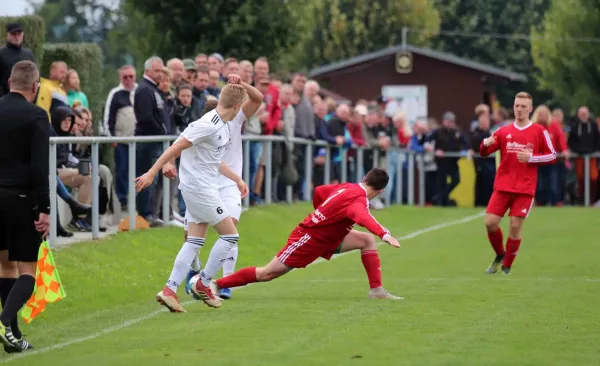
277 183 389 268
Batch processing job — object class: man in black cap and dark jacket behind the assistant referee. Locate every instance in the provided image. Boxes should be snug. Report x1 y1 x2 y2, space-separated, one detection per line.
0 23 35 97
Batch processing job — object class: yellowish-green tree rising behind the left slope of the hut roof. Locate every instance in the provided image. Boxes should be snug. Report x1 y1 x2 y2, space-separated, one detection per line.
290 0 440 68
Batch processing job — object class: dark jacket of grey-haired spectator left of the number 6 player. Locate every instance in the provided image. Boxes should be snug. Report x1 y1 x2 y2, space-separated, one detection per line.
133 78 169 136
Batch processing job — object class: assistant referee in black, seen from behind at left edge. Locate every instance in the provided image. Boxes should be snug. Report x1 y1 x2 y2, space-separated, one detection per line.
0 61 50 353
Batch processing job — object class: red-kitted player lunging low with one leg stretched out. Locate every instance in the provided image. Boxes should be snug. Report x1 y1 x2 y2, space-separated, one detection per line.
192 168 402 300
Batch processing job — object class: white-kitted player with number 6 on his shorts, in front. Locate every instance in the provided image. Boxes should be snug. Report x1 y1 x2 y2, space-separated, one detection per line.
136 74 263 312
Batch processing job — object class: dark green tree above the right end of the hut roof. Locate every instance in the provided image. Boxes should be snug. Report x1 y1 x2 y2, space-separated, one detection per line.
433 0 551 103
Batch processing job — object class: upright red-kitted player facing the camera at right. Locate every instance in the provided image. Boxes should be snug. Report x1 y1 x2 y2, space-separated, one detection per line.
479 92 556 275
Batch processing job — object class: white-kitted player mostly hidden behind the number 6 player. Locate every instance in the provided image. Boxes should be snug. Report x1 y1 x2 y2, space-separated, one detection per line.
183 98 245 300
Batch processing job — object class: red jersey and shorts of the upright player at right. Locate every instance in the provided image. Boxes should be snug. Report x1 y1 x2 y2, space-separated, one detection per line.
479 121 556 217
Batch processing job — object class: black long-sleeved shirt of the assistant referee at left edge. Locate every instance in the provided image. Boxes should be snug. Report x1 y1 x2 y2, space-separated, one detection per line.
0 92 50 214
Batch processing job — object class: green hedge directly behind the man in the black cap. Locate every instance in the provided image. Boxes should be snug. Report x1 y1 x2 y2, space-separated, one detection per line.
0 15 46 63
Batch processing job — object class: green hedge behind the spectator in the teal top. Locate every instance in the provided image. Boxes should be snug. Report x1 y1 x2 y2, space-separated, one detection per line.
40 43 106 131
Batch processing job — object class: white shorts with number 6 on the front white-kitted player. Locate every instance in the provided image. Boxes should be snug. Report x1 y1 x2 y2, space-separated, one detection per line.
181 189 229 226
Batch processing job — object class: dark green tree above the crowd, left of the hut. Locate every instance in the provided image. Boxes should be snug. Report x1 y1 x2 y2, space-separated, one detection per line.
124 0 297 60
